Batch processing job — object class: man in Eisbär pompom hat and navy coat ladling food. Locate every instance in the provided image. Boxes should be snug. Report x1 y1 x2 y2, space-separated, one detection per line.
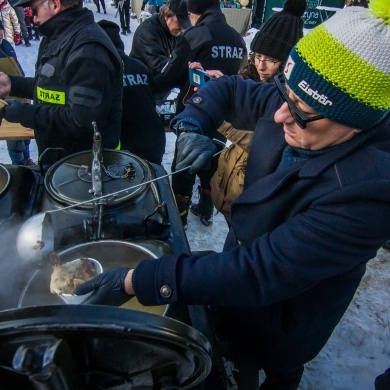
77 1 390 390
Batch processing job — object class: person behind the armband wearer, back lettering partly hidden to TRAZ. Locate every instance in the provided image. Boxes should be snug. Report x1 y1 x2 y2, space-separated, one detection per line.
98 20 165 165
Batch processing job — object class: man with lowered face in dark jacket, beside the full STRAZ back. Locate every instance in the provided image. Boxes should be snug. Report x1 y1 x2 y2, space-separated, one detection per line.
130 0 189 77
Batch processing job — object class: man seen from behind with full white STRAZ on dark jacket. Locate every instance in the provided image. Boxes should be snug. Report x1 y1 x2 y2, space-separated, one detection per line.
154 0 246 226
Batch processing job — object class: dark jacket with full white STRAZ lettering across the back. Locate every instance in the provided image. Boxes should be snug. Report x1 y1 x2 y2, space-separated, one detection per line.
154 8 246 112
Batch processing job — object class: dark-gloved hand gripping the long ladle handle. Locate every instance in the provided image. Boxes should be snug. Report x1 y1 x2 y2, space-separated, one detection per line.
176 133 216 173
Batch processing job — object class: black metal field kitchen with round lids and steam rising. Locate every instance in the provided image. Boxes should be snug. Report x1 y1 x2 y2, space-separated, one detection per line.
0 129 216 390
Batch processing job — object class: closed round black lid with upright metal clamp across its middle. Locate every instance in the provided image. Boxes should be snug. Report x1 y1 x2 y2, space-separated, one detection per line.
45 150 152 208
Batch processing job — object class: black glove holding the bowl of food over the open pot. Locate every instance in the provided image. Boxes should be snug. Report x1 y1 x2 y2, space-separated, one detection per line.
74 268 133 306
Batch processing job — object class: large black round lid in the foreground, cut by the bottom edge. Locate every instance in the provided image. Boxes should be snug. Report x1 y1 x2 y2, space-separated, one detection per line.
0 305 211 390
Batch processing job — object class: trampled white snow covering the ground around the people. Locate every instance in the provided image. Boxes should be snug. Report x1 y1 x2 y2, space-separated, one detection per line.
0 1 390 390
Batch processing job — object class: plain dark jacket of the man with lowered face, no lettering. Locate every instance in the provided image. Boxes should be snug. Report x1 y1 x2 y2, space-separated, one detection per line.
130 14 176 77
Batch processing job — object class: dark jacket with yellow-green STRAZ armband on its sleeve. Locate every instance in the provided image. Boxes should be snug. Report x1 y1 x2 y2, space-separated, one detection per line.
11 7 123 164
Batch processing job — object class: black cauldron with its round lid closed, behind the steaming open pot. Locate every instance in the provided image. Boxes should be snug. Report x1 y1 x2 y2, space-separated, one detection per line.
42 150 169 247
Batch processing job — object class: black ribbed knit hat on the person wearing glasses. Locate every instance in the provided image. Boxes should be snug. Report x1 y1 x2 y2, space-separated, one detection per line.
251 0 306 61
